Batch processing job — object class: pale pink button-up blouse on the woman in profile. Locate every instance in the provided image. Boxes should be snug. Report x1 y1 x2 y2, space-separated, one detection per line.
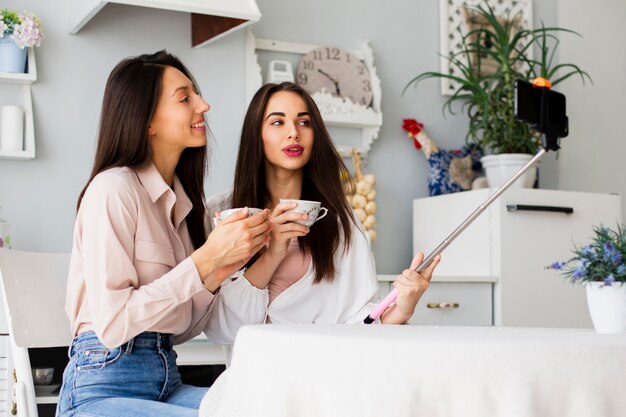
65 164 214 347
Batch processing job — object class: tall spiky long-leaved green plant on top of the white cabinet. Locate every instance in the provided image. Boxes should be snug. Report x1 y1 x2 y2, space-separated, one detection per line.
403 5 591 186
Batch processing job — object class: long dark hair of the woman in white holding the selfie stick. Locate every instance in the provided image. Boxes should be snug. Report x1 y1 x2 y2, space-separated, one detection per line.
233 82 355 283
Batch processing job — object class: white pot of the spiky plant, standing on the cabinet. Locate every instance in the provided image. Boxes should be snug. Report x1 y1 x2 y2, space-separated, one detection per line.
480 153 539 188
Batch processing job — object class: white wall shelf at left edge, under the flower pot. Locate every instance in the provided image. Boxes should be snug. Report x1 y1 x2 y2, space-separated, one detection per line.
0 48 37 161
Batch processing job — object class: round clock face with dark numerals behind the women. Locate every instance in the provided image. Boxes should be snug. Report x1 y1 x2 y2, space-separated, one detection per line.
296 47 372 106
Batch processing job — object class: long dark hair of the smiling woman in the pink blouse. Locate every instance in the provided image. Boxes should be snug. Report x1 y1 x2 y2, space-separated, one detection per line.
76 50 208 248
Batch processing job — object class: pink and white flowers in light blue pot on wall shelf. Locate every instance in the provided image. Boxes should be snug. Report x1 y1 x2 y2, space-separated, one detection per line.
0 9 43 72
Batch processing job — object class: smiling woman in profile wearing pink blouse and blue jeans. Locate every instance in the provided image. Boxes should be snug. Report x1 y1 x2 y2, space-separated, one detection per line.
57 51 269 417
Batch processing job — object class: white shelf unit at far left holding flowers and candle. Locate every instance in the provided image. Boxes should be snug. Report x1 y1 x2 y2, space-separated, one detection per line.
0 48 37 160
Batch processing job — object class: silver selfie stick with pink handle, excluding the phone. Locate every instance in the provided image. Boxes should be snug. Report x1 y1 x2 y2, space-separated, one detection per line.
363 148 546 324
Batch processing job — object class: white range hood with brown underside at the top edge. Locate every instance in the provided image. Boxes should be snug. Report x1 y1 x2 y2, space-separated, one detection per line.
70 0 261 47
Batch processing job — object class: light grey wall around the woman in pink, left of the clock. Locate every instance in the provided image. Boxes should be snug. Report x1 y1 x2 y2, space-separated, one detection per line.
0 0 245 251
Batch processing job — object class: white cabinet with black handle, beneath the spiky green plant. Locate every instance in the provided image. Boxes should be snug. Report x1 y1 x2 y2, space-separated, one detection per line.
413 189 621 327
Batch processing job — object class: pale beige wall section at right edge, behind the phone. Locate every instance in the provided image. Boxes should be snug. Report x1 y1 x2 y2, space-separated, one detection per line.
558 0 626 223
